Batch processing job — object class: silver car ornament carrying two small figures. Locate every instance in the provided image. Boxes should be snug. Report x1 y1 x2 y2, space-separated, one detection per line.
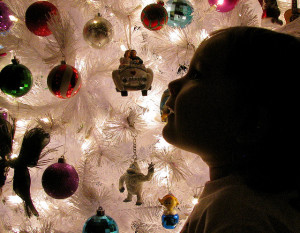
112 50 153 96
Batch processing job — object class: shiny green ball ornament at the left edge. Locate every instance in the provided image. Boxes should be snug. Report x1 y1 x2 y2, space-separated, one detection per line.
0 58 32 97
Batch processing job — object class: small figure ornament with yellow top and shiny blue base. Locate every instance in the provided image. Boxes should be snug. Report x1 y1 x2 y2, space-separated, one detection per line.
158 193 179 229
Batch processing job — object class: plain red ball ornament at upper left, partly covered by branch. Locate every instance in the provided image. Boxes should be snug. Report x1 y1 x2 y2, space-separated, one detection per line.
25 1 58 36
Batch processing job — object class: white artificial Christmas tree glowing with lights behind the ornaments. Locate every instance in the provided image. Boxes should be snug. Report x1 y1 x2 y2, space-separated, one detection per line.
0 0 291 233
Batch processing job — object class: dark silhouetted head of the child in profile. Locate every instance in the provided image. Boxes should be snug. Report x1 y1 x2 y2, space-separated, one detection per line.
163 27 300 191
